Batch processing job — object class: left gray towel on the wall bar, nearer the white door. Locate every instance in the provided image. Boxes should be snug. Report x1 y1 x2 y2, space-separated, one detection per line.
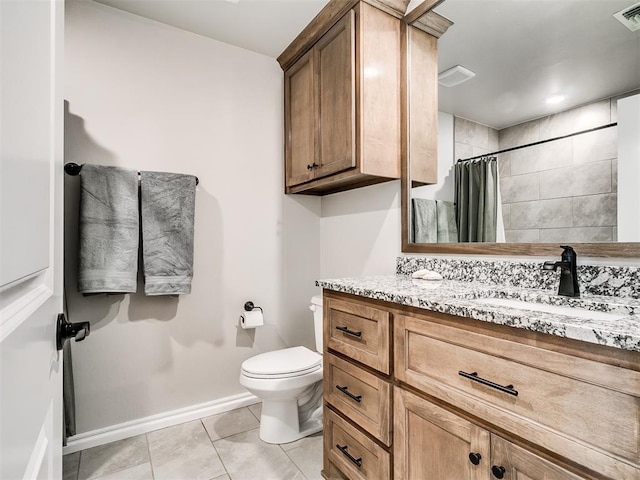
78 164 140 293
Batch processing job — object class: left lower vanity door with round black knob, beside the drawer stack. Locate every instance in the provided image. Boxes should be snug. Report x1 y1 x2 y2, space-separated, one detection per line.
393 387 490 480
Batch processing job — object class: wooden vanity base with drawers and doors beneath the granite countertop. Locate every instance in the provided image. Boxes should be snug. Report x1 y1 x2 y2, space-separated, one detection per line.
324 292 640 480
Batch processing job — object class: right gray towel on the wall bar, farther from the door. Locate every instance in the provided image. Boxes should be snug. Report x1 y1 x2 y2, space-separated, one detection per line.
140 172 196 295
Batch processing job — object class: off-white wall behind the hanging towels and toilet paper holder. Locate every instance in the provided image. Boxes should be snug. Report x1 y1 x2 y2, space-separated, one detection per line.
65 1 320 433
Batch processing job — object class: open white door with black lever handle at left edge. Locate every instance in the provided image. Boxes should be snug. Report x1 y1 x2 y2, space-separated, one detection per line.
0 0 64 480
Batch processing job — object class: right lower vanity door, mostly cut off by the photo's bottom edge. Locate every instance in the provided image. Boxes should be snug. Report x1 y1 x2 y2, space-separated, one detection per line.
490 435 583 480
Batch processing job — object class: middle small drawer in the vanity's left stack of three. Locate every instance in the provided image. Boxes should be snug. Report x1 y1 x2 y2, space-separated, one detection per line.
324 354 391 446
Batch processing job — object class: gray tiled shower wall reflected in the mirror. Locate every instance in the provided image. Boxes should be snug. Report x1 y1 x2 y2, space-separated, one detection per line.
455 99 617 242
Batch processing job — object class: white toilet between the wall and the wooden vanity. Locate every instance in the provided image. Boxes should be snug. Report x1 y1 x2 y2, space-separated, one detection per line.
240 295 322 443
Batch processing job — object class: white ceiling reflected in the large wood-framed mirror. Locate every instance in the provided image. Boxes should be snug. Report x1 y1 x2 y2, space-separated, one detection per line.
436 0 640 129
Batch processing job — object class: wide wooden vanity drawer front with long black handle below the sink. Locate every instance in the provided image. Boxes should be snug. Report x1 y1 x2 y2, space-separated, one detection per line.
394 315 640 465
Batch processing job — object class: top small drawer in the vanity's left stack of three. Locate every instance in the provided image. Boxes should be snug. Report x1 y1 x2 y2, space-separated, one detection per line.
324 295 391 375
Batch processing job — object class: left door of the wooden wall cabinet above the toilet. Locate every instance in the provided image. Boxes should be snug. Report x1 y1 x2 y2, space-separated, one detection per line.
284 51 317 186
